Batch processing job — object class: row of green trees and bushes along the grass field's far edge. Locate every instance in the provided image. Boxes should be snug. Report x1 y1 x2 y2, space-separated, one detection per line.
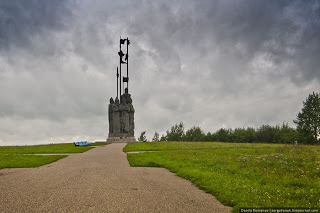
139 92 320 144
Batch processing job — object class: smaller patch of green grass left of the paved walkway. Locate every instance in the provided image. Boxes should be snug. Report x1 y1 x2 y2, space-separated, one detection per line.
0 143 108 169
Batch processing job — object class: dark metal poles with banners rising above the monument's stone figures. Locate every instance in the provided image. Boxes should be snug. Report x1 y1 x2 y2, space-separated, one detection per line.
117 37 130 97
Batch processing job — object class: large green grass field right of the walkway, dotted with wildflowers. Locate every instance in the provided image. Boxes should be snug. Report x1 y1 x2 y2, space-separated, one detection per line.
124 142 320 212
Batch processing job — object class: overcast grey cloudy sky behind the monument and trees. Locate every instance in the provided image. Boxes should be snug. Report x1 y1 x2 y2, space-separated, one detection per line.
0 0 320 145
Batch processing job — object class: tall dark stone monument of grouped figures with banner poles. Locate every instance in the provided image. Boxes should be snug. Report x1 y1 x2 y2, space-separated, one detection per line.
107 37 136 143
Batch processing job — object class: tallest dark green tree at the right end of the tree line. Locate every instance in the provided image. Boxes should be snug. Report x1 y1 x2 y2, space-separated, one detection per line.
293 92 320 143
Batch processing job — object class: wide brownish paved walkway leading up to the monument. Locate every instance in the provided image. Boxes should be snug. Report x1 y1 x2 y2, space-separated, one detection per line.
0 143 231 212
